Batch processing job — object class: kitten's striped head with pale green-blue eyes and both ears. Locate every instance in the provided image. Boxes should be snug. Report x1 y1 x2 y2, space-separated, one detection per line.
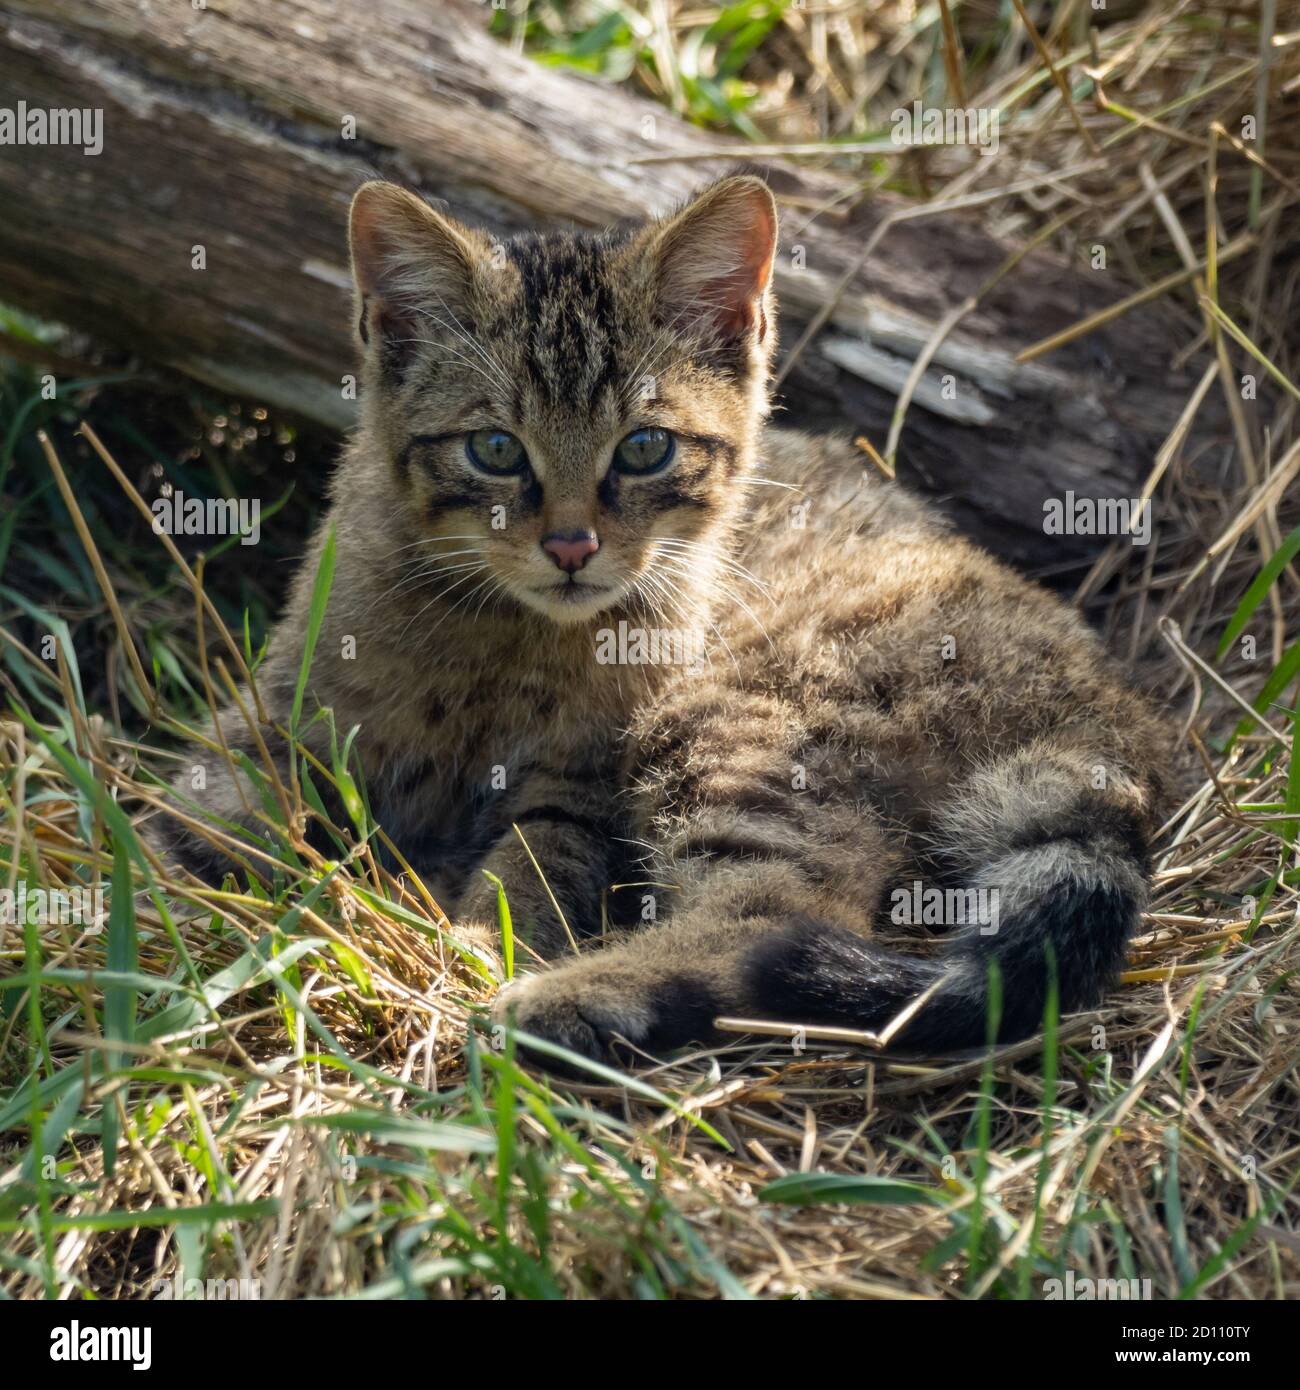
352 177 776 623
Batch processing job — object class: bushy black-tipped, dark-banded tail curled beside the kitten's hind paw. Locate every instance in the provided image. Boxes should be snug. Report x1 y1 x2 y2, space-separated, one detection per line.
747 805 1148 1052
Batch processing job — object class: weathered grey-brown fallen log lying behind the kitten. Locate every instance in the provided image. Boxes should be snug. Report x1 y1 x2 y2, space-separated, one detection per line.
0 0 1217 566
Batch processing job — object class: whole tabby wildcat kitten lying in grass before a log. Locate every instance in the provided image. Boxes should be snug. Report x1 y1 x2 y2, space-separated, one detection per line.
157 177 1169 1058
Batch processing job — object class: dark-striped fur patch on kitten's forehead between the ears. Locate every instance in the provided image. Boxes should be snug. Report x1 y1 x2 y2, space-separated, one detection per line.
506 235 623 410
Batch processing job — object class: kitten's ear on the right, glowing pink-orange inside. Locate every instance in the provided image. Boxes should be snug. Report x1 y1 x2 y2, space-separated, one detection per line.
651 174 776 342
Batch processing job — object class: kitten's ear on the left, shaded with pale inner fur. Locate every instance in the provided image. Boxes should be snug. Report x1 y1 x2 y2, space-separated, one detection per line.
349 181 484 363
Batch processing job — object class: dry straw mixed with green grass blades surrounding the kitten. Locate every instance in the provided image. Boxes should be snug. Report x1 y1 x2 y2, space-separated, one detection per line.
0 0 1300 1298
